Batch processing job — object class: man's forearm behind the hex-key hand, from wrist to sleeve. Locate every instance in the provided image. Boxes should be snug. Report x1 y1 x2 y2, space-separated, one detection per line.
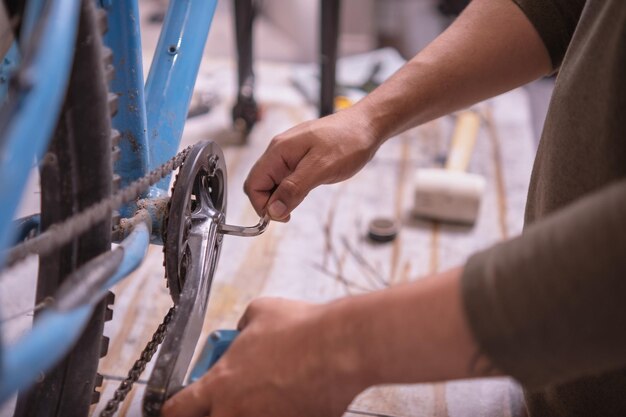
351 0 551 142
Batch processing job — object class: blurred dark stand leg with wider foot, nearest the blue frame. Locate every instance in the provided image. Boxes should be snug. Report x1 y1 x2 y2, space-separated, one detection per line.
232 0 259 140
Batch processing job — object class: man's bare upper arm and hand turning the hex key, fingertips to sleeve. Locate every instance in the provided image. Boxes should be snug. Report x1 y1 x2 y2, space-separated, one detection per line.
244 0 551 221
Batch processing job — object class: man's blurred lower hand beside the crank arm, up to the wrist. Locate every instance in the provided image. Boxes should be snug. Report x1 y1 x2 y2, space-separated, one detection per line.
162 298 365 417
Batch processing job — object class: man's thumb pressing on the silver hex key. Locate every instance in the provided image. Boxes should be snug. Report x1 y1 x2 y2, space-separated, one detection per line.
266 166 319 221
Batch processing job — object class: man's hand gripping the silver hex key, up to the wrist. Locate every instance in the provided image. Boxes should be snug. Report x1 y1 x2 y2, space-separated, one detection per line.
244 109 379 221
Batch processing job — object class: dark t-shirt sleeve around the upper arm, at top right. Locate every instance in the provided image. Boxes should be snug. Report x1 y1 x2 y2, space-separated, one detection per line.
513 0 585 69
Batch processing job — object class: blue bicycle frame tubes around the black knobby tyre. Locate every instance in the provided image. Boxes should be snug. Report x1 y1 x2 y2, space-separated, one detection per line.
0 0 217 404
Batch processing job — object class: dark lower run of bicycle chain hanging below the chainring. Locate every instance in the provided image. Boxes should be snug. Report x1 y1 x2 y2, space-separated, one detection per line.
99 307 175 417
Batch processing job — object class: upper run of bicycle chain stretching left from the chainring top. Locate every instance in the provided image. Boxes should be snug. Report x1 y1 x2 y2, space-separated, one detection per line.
5 146 191 268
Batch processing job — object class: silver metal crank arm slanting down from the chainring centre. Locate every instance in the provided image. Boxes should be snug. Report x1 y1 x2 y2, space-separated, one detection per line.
143 204 223 416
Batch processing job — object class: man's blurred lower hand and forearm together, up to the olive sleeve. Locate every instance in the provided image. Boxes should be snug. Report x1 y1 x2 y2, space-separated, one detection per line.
163 269 493 417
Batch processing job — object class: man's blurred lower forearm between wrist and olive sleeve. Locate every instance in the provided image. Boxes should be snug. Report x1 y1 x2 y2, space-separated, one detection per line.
321 269 490 389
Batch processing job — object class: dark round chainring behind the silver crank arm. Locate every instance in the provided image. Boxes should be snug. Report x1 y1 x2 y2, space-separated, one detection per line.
163 141 227 304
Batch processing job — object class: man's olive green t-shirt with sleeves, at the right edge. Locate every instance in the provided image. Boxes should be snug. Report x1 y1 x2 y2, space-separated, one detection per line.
463 0 626 417
